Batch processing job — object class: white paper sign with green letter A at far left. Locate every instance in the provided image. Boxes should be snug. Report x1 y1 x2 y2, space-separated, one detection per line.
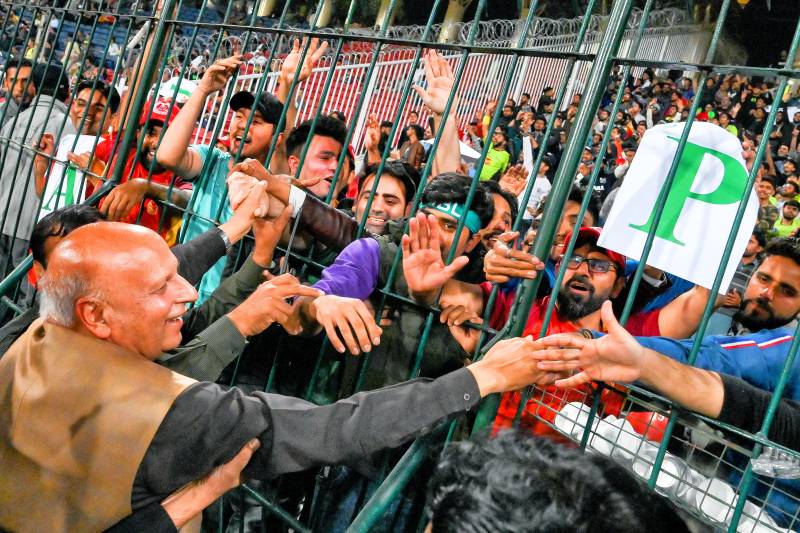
39 135 95 220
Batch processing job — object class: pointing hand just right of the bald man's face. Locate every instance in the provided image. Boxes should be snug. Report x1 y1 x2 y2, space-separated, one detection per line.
228 274 320 337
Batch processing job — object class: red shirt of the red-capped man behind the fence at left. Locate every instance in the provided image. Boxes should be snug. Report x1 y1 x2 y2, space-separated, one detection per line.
92 133 192 237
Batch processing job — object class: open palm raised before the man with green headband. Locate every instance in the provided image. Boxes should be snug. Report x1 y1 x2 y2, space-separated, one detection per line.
400 213 469 304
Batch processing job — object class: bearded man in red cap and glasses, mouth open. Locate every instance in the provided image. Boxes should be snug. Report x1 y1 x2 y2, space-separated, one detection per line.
484 227 709 434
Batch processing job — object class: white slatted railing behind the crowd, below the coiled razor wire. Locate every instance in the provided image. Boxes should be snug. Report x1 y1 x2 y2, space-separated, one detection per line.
180 13 710 154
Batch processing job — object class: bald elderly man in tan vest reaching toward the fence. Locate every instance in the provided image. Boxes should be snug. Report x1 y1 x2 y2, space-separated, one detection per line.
0 223 556 532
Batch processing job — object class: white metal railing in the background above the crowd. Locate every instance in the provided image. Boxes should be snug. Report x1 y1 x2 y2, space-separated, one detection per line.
184 9 710 158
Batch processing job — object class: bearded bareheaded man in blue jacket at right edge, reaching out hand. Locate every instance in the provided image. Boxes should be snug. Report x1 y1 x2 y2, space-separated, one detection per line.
540 238 800 527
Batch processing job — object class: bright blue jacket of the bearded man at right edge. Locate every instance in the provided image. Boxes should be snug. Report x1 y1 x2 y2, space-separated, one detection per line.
636 328 800 527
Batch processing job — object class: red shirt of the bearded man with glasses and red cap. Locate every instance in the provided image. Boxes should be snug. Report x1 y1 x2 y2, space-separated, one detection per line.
481 283 661 438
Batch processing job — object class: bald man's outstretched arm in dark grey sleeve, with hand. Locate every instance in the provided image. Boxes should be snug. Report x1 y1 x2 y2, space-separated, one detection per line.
138 337 554 494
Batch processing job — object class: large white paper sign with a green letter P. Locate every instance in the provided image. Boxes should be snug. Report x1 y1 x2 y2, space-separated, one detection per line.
599 122 758 293
